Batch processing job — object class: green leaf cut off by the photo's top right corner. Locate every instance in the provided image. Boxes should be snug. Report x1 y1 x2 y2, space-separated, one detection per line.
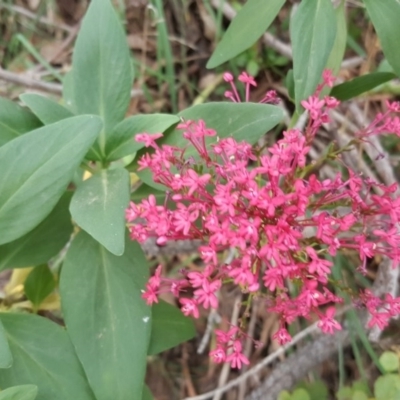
363 0 400 76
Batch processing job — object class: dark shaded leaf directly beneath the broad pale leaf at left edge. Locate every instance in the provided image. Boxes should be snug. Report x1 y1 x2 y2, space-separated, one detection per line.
0 192 73 271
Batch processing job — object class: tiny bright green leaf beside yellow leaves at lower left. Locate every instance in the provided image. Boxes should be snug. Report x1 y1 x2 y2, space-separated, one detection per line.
24 264 56 309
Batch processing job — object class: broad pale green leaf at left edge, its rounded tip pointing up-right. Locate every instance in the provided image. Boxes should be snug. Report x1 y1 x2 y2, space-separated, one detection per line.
0 116 101 244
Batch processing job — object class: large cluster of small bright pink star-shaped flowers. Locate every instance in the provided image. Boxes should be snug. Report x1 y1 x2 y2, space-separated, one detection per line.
126 74 400 368
